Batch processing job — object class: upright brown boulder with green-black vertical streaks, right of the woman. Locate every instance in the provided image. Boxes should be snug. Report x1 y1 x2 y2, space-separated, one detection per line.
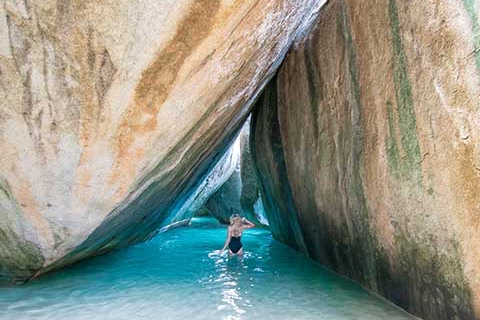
251 0 480 320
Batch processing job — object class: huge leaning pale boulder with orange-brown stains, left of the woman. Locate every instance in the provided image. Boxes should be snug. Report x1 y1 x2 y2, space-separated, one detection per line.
0 0 323 281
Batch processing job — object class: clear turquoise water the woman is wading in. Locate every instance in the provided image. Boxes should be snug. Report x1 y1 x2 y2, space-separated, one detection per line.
0 218 412 320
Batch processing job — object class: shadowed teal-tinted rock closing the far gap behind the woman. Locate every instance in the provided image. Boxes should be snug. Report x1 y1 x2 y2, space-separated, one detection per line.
205 120 267 226
